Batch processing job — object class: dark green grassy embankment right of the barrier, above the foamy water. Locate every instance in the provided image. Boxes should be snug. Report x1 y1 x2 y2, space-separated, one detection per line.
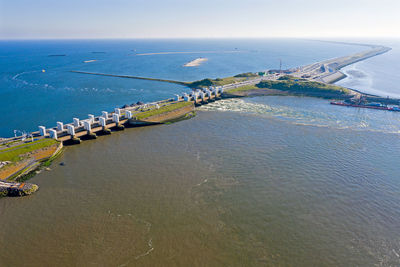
226 76 354 99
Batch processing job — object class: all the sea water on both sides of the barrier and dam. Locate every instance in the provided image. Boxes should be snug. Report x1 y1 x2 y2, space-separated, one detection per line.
0 39 400 266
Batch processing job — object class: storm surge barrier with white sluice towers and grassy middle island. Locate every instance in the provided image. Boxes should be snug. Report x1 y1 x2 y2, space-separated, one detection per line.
23 87 224 144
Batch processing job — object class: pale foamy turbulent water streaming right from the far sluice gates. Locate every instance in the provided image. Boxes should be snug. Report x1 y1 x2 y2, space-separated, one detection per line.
200 96 400 133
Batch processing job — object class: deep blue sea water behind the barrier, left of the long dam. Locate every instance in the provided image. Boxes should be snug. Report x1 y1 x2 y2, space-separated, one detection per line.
0 39 365 137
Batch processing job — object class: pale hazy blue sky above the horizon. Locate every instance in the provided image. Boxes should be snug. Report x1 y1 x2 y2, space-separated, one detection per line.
0 0 400 39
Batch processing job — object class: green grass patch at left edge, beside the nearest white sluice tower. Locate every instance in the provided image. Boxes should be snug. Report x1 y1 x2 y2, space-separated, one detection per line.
0 138 58 162
